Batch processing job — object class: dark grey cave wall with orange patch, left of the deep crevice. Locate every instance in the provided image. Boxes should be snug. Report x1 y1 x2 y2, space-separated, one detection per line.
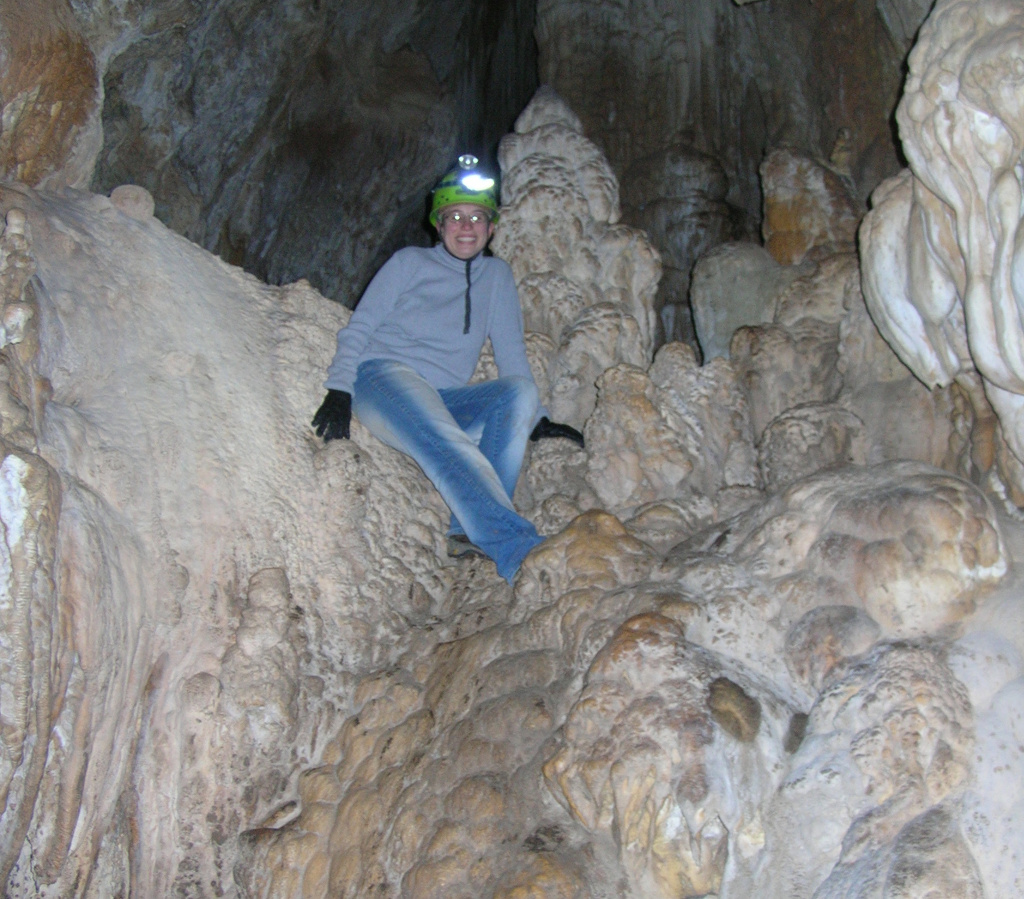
0 0 537 305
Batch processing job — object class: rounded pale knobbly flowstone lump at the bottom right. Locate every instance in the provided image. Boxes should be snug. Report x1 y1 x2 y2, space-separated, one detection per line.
758 644 984 897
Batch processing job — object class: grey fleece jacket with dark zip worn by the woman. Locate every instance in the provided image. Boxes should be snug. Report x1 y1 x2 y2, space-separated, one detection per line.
324 244 532 393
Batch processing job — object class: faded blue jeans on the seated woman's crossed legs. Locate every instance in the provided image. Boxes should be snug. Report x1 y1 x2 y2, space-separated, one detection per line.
352 359 543 584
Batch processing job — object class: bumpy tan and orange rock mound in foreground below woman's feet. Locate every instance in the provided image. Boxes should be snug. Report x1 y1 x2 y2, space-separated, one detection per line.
239 465 1020 899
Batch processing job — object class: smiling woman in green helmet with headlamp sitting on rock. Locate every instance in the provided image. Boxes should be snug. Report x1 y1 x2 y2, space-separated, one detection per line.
312 156 584 583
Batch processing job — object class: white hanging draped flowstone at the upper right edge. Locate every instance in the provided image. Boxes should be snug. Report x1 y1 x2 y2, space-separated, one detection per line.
860 0 1024 506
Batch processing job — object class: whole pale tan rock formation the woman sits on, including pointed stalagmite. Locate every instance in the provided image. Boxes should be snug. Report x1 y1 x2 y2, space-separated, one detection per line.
0 59 1024 899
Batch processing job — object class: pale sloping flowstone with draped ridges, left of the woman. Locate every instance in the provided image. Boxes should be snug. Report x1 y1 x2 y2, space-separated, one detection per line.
3 181 458 895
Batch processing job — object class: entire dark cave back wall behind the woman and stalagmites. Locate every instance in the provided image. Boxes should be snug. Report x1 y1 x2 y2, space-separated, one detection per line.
0 0 931 331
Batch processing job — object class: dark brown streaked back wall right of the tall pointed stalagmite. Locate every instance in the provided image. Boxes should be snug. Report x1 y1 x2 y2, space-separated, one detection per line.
537 0 931 347
